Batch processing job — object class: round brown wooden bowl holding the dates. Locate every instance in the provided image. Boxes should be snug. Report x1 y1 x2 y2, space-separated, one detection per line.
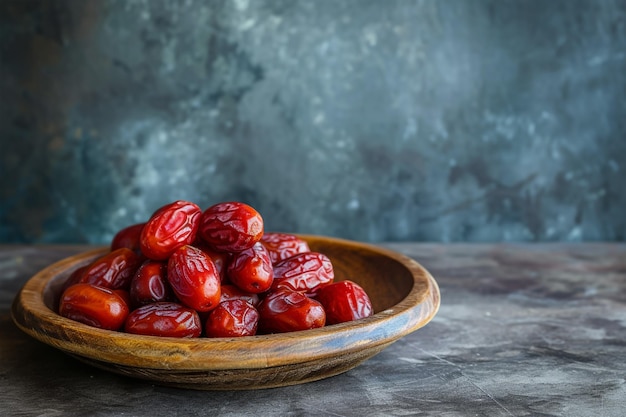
11 235 440 390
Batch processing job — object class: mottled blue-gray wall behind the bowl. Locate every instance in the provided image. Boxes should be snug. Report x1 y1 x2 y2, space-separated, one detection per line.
0 0 626 243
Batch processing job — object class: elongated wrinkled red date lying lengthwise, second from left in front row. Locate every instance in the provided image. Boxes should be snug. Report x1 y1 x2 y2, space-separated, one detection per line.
124 302 202 337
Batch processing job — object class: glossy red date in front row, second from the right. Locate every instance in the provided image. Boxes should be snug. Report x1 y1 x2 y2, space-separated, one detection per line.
258 289 326 333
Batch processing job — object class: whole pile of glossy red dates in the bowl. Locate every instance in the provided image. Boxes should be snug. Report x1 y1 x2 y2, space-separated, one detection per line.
58 200 372 337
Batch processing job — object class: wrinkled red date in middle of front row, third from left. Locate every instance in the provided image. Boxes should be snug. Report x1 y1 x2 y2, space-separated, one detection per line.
205 300 259 337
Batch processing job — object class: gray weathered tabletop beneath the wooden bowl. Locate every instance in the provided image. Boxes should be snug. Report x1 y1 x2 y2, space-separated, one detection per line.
0 243 626 417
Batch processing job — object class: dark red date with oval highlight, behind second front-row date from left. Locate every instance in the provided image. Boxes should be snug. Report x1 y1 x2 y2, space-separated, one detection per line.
129 261 173 307
